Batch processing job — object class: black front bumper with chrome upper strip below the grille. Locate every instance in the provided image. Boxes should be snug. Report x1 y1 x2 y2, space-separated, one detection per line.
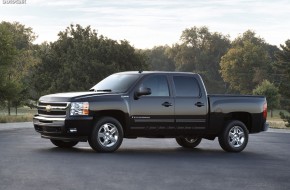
33 115 93 141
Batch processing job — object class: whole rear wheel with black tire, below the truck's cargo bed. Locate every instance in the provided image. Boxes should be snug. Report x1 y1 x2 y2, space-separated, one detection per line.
218 120 249 152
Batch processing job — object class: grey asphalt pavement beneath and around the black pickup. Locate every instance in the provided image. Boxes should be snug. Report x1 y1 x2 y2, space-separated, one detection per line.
0 122 290 190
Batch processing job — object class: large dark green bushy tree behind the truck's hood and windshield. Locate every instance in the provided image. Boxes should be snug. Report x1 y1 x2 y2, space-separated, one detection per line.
30 24 146 98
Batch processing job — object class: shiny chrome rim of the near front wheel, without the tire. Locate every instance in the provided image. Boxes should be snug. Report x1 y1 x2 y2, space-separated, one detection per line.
98 123 119 147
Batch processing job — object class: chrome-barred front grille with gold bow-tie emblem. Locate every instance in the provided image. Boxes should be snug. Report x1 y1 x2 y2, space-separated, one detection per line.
37 102 69 117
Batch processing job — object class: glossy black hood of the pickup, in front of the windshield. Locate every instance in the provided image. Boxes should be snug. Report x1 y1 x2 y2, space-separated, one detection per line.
39 92 118 102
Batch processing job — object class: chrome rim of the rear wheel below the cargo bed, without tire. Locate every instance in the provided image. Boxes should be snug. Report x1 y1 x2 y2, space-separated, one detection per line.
228 126 245 148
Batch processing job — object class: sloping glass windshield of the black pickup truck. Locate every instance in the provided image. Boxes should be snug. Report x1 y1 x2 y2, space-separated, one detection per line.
90 74 140 92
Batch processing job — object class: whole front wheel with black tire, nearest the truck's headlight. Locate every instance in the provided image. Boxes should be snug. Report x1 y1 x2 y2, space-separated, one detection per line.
88 117 124 153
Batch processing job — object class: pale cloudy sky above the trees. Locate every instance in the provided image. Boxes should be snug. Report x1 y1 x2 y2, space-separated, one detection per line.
0 0 290 49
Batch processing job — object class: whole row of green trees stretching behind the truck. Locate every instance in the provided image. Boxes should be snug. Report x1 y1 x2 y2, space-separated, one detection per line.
0 22 290 125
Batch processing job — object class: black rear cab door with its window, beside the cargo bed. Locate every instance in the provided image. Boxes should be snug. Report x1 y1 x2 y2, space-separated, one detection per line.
172 75 208 131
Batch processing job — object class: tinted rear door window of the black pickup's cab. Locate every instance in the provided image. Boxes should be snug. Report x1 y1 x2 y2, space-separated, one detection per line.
173 76 200 97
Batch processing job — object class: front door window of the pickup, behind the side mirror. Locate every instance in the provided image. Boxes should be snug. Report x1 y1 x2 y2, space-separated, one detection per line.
140 75 169 96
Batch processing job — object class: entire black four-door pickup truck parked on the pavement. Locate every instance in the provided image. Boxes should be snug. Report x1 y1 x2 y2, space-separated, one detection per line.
33 71 268 152
